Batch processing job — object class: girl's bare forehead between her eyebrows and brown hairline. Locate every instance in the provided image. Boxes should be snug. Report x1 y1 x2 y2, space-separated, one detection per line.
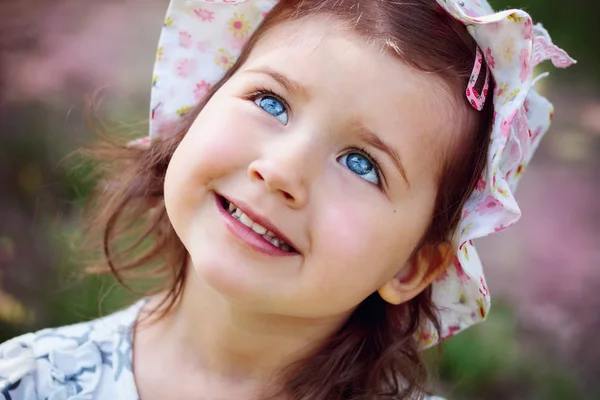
241 17 462 175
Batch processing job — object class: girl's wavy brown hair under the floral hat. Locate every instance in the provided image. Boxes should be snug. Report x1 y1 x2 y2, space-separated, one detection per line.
85 0 494 400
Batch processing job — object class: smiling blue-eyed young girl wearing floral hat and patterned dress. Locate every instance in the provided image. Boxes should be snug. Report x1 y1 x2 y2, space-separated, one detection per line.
0 0 573 400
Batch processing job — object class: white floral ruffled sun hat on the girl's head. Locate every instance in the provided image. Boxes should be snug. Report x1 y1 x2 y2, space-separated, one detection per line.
132 0 575 348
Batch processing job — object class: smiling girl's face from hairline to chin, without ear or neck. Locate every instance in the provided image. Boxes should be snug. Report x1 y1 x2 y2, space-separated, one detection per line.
165 19 458 318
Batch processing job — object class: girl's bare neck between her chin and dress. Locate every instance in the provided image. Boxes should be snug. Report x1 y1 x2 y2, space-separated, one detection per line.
144 269 347 396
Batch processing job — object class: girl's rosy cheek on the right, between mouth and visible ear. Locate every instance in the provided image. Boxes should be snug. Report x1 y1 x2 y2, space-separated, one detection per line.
311 181 433 296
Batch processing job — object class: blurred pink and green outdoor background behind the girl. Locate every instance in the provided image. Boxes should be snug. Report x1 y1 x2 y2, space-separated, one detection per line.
0 0 600 400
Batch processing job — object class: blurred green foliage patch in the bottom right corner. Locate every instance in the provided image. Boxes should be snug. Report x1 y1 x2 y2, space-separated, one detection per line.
426 301 598 400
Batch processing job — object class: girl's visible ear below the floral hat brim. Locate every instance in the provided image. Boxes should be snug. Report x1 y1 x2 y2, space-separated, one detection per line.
378 242 454 304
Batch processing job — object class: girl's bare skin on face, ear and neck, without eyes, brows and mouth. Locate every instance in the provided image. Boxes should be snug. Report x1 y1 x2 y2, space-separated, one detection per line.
134 19 457 400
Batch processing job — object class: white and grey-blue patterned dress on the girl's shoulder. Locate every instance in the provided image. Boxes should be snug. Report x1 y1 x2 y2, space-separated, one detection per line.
0 300 443 400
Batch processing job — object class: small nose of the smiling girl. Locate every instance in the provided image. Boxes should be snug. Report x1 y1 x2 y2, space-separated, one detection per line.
248 151 309 209
